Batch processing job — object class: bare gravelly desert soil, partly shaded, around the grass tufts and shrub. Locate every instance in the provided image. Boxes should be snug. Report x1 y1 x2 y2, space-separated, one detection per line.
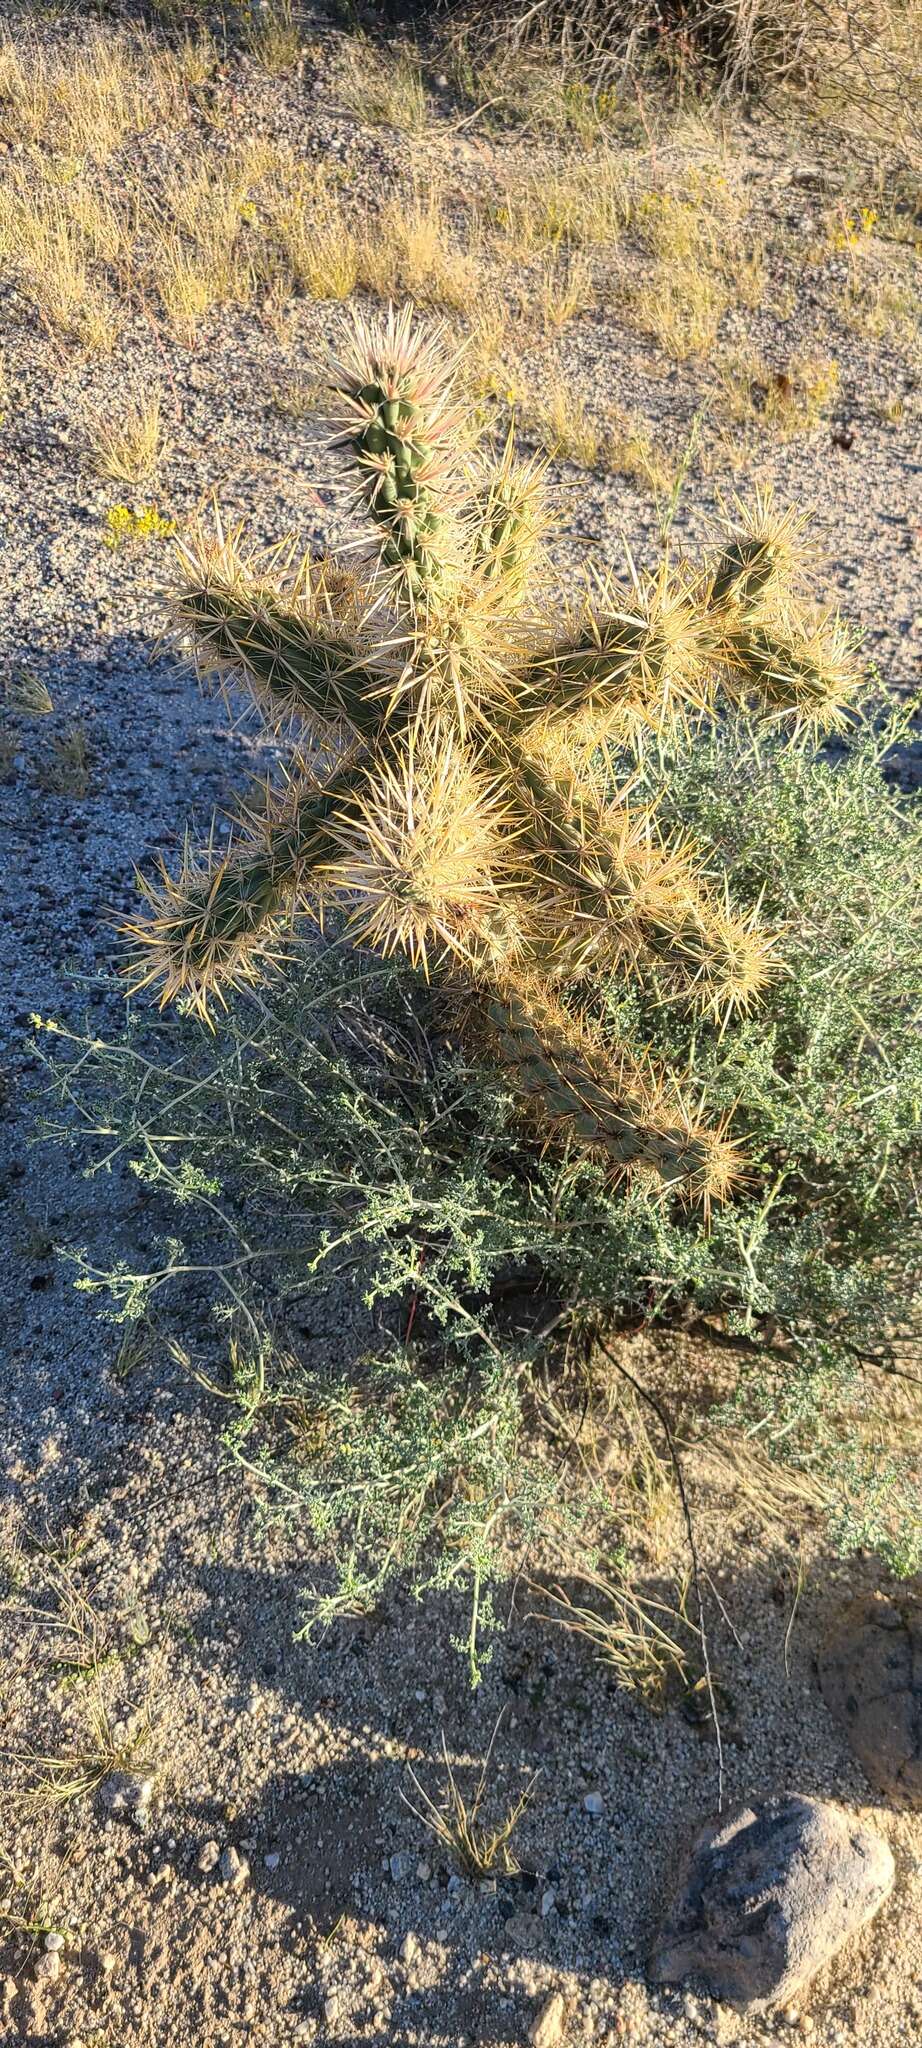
0 8 922 2048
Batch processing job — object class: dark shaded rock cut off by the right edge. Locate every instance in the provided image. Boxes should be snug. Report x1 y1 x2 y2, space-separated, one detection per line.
818 1593 922 1810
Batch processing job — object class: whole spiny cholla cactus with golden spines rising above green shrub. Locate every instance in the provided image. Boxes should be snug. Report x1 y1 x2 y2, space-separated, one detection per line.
131 307 854 1202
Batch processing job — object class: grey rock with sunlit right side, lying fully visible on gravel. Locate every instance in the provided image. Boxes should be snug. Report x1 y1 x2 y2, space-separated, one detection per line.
649 1794 893 2011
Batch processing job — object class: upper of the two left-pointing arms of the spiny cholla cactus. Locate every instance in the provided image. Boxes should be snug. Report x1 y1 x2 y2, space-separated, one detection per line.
176 565 387 739
